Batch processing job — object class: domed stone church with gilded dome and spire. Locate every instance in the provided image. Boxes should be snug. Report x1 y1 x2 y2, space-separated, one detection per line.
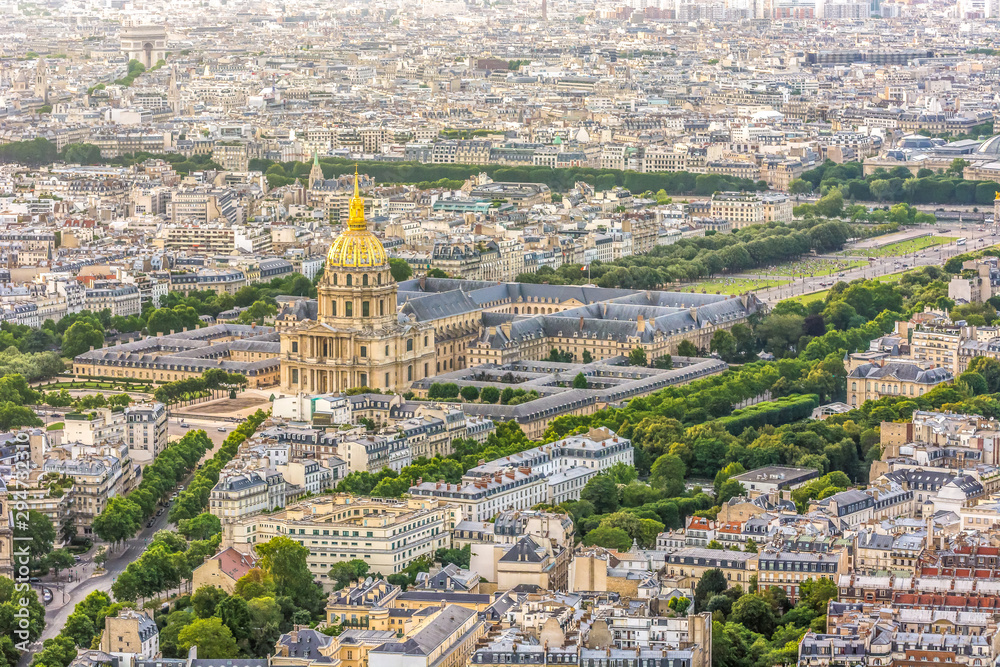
281 176 435 394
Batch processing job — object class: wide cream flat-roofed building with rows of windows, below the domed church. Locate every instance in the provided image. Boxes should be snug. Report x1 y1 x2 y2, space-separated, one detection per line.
223 494 463 590
